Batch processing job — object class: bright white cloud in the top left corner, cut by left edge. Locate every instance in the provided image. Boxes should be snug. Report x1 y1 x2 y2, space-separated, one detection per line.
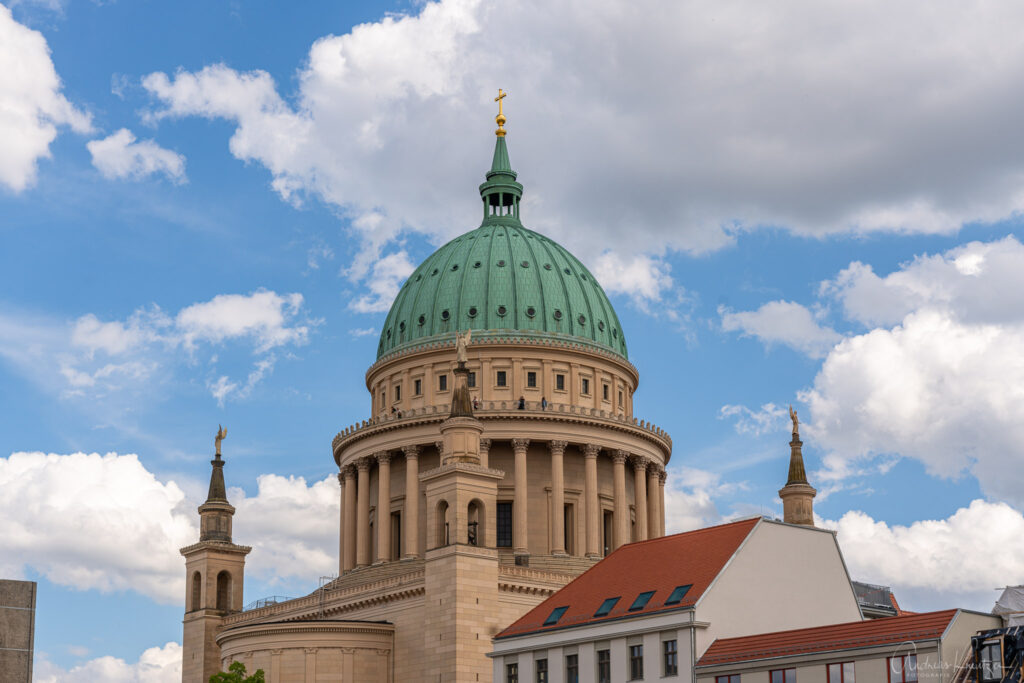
0 5 92 193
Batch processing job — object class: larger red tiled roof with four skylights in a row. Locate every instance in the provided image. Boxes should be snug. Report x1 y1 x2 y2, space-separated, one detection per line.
496 518 760 638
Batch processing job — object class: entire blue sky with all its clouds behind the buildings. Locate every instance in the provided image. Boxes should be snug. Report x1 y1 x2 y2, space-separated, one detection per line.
0 0 1024 680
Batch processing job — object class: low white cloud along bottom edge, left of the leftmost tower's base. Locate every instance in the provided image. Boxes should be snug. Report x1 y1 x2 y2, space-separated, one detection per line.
32 642 181 683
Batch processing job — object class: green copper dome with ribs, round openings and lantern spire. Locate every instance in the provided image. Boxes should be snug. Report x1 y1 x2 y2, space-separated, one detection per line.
377 131 628 358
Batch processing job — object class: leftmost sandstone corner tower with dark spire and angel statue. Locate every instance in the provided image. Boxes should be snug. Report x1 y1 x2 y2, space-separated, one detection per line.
181 428 252 683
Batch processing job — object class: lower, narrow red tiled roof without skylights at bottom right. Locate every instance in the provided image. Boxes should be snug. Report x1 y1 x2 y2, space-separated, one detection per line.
697 609 957 667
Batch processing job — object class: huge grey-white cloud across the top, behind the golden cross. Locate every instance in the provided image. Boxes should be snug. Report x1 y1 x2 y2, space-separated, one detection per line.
143 0 1024 305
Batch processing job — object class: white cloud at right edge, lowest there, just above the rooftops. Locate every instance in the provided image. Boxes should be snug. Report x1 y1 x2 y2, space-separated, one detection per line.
818 500 1024 611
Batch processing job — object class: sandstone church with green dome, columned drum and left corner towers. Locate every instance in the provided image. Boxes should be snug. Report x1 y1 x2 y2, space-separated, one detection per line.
181 102 672 683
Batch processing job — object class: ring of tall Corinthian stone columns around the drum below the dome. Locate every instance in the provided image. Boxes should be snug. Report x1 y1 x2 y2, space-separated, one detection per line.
338 438 666 571
